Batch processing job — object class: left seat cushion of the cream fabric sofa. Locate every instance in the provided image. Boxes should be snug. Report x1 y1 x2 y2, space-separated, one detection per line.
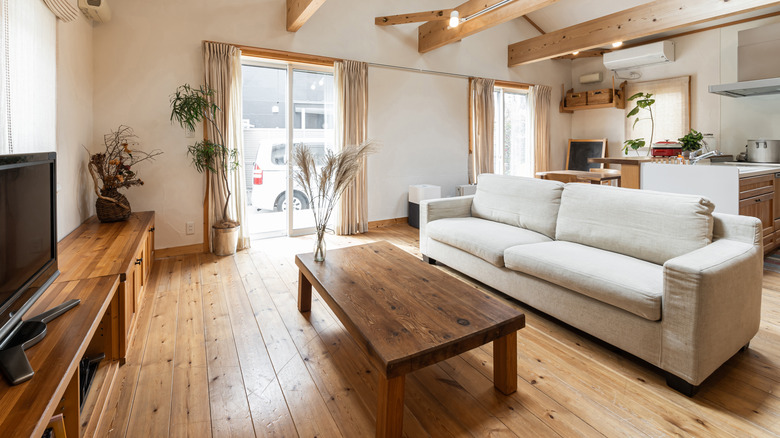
427 217 550 268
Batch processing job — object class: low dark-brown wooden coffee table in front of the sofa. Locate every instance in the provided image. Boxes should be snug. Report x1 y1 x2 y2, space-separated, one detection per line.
295 242 525 437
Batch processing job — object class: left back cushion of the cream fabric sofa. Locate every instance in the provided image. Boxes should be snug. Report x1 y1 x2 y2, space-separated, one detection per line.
471 173 563 239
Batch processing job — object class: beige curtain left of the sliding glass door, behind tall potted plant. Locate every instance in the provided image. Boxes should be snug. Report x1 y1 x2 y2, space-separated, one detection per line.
203 42 249 250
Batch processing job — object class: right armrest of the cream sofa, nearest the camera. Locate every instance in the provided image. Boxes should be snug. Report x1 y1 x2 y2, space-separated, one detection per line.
660 239 763 385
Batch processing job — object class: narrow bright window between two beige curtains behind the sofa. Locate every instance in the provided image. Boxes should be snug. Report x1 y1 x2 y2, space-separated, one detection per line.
493 87 534 177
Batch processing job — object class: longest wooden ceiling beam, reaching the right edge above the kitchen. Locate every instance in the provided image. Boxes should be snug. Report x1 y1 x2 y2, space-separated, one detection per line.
509 0 780 66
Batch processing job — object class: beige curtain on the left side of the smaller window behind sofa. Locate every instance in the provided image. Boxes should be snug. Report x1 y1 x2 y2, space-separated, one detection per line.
469 78 496 184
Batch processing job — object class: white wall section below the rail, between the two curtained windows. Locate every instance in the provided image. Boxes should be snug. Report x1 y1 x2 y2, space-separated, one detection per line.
368 68 469 220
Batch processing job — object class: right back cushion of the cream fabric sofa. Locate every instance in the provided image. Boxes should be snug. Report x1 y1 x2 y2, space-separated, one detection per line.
555 184 714 265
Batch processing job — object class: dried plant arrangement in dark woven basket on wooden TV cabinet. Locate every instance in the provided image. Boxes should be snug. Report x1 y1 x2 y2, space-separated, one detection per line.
87 125 162 222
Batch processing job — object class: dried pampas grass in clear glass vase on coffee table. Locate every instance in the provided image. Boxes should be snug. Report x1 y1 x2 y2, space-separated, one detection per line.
293 140 375 262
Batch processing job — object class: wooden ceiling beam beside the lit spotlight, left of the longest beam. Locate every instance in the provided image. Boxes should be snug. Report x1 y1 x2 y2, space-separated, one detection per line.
417 0 558 53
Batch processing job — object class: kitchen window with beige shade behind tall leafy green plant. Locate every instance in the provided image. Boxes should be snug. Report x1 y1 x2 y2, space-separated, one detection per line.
625 76 691 147
